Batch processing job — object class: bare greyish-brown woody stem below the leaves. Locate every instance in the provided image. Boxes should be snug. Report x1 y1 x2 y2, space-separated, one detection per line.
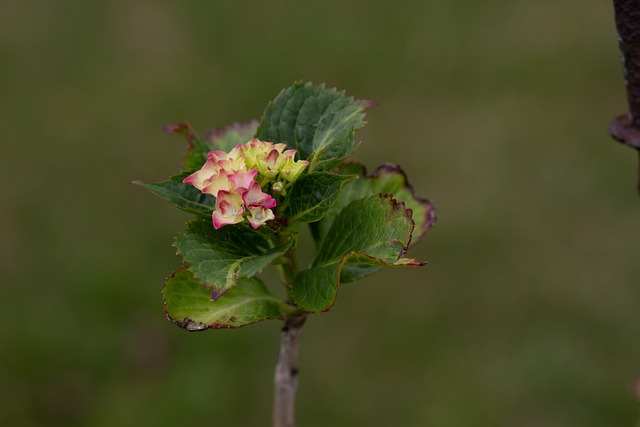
273 314 306 427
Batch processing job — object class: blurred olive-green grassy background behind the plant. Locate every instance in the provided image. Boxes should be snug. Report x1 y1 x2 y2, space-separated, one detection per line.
0 0 640 427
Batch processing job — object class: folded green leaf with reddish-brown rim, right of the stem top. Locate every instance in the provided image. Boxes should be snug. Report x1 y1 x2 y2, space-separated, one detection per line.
292 195 423 313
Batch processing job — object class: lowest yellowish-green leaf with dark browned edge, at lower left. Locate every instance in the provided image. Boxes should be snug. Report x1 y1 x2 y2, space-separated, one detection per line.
162 269 287 331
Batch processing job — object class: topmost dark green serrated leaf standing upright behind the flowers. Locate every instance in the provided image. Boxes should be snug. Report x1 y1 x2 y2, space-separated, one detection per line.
256 83 375 171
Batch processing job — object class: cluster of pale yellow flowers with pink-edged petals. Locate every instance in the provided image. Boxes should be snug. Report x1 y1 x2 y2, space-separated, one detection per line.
182 138 309 229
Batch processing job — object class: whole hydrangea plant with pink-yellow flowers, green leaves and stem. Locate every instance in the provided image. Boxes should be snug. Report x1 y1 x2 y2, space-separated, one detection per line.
136 83 436 426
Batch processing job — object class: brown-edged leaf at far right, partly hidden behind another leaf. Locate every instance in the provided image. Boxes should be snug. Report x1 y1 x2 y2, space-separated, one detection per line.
312 163 436 251
